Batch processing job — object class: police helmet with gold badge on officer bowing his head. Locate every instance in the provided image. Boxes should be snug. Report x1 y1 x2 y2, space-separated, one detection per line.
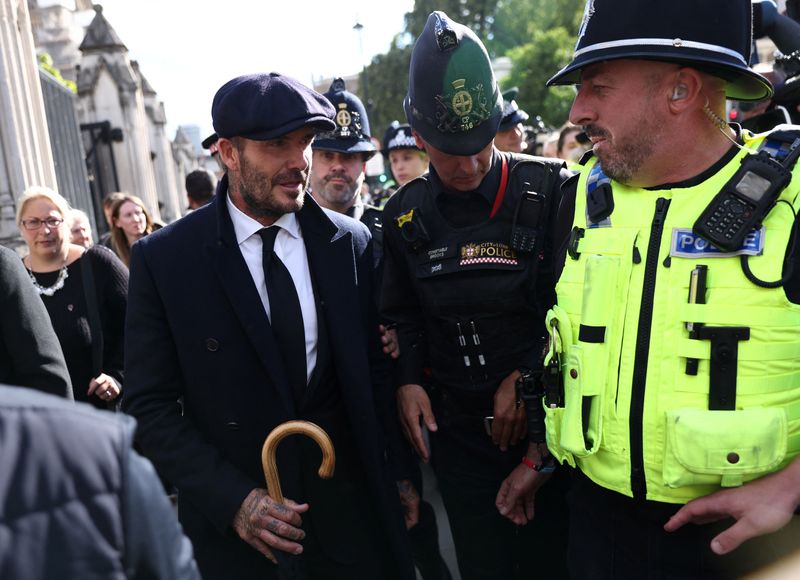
403 11 503 155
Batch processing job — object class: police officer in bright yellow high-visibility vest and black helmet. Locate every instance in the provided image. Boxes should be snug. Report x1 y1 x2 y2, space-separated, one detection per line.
496 0 800 579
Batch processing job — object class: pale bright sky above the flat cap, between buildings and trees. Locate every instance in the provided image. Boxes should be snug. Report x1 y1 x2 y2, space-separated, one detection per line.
85 0 414 139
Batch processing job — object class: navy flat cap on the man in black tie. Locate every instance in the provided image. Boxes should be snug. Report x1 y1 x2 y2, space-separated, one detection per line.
211 73 336 141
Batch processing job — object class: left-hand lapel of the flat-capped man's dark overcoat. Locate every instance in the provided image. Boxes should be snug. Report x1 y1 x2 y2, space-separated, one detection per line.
206 175 294 415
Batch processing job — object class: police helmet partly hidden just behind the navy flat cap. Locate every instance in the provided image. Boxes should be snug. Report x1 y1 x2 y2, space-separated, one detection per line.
311 78 377 161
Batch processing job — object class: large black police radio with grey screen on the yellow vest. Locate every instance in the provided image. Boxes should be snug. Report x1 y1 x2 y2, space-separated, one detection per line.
692 151 792 252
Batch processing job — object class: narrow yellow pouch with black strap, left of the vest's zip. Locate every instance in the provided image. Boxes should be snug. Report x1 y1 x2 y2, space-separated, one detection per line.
559 344 603 457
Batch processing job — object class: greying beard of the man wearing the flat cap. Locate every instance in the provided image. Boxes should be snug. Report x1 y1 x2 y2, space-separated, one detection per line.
239 158 308 218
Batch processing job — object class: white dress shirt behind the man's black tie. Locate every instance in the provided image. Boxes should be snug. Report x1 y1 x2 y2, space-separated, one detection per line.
227 195 317 380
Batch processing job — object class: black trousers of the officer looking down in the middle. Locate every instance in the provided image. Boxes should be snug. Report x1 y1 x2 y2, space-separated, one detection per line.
430 421 570 580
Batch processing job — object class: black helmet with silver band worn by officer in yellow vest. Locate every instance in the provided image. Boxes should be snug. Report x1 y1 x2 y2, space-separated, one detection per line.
547 0 772 101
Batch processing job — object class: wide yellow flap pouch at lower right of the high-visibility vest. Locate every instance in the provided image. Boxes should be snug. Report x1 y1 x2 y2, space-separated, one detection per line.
663 407 788 488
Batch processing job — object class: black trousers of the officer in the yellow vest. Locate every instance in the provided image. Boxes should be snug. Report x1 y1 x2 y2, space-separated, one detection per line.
569 471 800 580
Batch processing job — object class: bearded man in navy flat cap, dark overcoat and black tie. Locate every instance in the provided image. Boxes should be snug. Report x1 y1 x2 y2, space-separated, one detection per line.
124 73 413 580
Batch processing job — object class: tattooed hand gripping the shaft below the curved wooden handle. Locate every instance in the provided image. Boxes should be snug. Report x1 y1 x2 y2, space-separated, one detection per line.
233 489 308 564
